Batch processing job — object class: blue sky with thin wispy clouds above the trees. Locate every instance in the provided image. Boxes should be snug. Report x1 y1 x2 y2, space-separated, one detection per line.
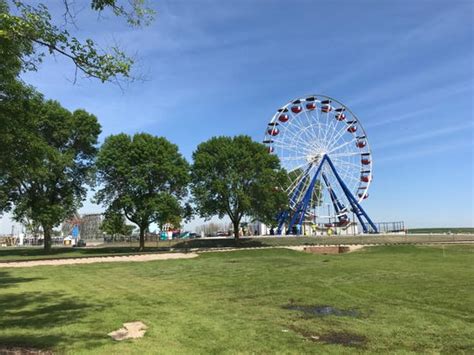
0 0 474 232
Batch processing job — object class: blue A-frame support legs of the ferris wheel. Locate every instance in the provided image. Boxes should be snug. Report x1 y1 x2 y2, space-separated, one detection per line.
277 155 379 235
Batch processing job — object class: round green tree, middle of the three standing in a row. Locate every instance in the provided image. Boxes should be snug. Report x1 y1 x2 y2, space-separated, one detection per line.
96 133 189 250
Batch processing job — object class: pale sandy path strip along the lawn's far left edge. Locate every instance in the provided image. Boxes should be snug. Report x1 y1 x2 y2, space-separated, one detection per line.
0 253 198 268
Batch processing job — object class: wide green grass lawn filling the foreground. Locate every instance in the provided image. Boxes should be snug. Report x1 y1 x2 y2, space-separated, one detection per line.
0 245 474 354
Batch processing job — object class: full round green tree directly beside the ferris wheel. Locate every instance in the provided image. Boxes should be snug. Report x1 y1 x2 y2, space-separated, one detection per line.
191 136 287 239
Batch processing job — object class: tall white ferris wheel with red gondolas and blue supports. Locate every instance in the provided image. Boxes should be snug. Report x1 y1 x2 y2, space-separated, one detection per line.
263 95 378 234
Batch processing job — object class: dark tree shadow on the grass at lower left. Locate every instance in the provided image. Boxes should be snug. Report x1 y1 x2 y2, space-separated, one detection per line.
0 273 108 353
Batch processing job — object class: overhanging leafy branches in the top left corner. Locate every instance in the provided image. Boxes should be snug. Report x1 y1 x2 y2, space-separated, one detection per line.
0 0 154 82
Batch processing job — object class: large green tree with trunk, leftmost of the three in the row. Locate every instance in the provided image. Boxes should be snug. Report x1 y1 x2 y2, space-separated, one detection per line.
0 94 100 250
